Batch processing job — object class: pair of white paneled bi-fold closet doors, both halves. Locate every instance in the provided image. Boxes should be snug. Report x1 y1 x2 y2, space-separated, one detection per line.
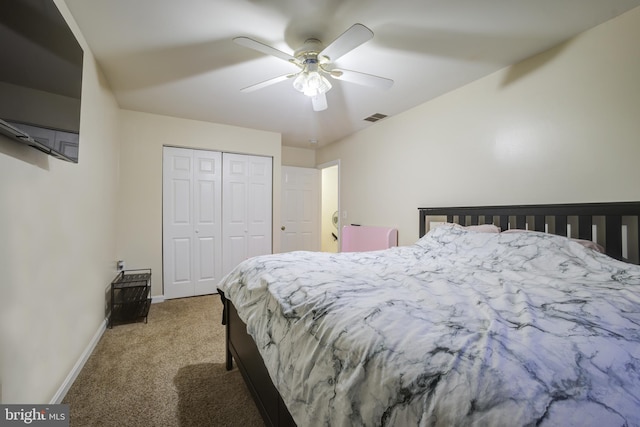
163 147 272 298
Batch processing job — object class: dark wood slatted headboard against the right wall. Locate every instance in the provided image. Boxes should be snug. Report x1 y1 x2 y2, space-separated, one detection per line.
419 202 640 264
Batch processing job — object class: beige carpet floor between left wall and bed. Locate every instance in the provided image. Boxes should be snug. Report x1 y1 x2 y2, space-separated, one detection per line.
63 295 264 427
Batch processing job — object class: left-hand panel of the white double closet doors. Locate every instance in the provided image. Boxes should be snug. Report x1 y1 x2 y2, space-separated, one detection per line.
162 147 222 298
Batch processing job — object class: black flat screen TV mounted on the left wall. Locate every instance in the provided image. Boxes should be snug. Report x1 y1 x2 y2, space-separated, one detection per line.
0 0 84 163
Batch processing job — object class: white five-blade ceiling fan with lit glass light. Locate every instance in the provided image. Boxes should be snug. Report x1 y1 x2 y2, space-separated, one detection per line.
233 24 393 111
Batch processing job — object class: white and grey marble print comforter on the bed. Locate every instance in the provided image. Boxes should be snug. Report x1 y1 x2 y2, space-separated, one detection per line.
219 225 640 427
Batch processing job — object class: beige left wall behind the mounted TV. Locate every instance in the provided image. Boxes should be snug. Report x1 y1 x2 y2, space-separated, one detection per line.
0 1 118 404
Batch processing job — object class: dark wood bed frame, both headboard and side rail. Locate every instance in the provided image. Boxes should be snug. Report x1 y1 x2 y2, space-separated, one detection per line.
218 202 640 427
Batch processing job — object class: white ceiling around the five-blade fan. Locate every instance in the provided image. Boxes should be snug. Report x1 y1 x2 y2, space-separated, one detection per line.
65 0 640 148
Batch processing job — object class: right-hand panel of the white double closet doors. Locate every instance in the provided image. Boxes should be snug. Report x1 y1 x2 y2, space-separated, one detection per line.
222 153 273 274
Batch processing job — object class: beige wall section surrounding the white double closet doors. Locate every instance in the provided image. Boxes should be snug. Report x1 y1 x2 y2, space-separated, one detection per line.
117 110 281 296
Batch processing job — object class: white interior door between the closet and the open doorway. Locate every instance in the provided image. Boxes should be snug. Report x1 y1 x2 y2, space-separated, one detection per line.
281 166 320 252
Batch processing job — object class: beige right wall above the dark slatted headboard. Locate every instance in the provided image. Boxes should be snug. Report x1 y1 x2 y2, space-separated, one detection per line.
316 8 640 244
